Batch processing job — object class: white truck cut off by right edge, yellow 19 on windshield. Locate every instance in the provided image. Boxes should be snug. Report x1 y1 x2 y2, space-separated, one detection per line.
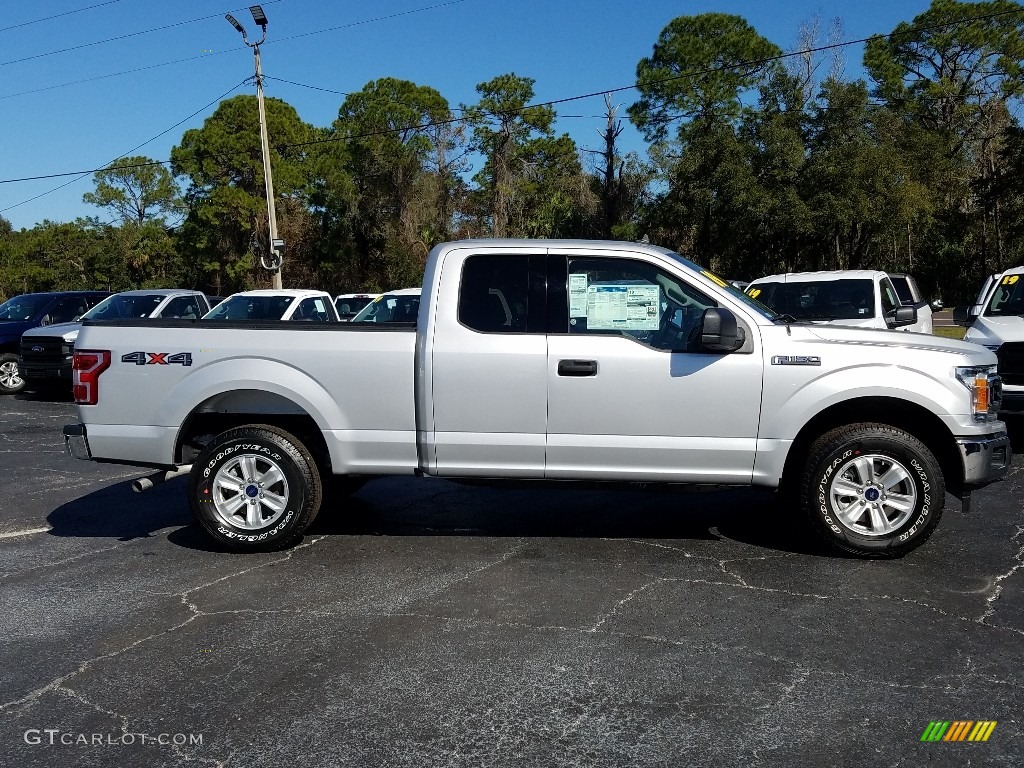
953 265 1024 414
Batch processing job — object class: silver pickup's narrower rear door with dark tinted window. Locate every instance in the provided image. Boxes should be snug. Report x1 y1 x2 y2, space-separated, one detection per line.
420 247 548 478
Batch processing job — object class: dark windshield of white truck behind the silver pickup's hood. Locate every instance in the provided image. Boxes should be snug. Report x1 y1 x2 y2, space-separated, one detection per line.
748 279 874 321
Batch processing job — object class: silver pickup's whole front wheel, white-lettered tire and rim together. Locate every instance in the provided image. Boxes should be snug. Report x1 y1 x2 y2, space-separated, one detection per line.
799 424 946 558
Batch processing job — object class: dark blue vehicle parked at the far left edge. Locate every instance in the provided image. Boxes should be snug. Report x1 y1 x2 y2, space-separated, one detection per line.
0 291 111 394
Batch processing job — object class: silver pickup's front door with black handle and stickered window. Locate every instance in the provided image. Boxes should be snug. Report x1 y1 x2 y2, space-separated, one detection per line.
546 255 763 483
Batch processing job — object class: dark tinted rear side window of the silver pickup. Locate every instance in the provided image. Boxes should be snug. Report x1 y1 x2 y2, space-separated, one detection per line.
459 255 529 334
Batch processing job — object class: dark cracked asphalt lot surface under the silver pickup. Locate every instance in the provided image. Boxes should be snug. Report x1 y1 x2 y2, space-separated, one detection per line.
0 397 1024 768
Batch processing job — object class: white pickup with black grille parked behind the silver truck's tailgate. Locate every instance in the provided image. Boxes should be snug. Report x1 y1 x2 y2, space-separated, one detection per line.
20 288 210 390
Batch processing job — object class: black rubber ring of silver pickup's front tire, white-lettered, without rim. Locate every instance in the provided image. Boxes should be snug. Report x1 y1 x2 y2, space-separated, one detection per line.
805 433 945 555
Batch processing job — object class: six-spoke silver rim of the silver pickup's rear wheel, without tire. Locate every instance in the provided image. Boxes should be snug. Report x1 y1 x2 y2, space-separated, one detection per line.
210 454 289 530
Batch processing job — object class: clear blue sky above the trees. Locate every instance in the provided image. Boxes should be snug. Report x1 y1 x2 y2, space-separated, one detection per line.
0 0 929 229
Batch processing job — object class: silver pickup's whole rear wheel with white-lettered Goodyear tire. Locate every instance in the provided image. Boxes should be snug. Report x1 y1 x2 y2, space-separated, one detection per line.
188 424 323 552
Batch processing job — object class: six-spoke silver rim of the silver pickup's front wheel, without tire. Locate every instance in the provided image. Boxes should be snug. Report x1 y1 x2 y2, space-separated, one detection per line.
828 454 918 537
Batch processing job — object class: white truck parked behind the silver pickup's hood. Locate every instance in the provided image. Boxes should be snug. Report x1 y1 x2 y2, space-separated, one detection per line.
746 269 932 334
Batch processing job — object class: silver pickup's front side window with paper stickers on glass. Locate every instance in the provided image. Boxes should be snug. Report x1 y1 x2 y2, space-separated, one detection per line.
568 259 717 351
